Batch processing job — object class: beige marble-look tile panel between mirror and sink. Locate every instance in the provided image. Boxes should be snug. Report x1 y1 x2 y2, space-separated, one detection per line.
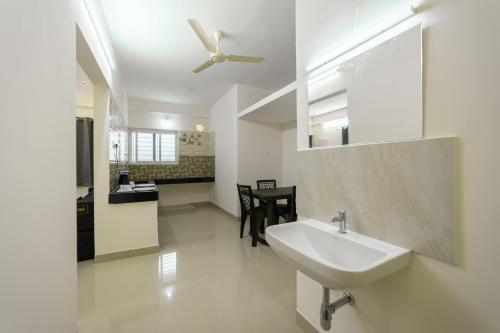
296 138 456 263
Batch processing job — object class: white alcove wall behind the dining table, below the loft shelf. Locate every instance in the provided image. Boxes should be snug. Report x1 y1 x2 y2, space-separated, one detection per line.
238 119 282 187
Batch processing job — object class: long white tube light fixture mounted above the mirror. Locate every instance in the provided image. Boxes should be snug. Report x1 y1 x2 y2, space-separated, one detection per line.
307 6 417 80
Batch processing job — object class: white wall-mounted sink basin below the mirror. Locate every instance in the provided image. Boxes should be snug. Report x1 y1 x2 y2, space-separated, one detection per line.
266 220 411 289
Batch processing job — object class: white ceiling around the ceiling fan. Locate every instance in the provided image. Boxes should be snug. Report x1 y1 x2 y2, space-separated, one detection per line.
102 0 295 105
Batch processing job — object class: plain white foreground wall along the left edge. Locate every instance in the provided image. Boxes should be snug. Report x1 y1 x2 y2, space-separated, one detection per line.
0 0 77 333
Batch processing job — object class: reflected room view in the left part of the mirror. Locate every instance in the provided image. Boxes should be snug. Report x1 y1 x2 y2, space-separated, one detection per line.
309 89 349 148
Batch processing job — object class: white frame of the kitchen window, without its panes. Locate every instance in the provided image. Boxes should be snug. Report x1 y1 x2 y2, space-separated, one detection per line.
127 128 179 165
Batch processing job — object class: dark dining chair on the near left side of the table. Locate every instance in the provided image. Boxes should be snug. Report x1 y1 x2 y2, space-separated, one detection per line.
236 184 266 246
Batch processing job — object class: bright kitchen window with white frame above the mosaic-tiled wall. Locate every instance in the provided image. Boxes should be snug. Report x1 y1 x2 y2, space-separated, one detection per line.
129 129 179 164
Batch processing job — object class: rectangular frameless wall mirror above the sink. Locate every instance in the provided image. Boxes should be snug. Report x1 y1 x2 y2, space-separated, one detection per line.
308 25 422 147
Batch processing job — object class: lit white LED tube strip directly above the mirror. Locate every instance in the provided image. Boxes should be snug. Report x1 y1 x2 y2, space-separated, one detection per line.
307 6 417 84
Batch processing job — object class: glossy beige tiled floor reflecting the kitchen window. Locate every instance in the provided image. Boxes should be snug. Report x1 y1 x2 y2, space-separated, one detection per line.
78 206 302 333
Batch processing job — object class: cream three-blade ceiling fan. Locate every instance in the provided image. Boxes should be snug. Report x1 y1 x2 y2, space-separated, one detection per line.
188 19 264 73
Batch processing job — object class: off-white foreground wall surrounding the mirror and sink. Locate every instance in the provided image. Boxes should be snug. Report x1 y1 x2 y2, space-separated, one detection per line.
296 0 500 333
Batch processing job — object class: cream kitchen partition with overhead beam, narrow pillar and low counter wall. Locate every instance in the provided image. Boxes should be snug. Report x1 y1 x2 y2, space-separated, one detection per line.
72 0 158 256
